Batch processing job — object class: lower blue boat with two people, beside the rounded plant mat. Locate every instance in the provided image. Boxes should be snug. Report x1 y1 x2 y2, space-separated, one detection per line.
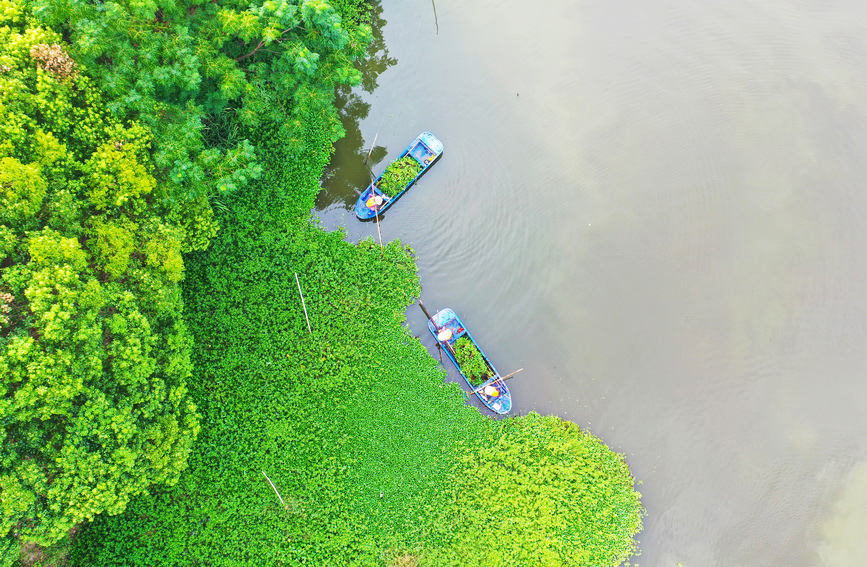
427 309 512 414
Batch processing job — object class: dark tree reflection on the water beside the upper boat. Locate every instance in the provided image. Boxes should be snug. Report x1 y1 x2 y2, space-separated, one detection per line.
316 0 397 210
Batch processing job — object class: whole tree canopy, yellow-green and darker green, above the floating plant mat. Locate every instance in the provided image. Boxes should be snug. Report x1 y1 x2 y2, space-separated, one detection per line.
0 0 370 559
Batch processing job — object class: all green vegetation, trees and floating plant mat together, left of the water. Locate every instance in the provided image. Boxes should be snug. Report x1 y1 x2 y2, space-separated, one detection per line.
0 0 642 566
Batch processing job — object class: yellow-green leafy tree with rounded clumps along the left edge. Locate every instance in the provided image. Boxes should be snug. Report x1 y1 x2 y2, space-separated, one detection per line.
0 7 204 564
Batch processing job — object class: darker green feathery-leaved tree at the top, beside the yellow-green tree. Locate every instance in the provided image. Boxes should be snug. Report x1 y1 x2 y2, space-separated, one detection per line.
34 0 371 204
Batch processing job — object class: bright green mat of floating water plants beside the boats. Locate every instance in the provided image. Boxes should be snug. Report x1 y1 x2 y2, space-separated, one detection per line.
72 98 641 567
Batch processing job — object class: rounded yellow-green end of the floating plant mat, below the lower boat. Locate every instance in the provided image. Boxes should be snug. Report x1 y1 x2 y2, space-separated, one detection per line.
432 413 643 567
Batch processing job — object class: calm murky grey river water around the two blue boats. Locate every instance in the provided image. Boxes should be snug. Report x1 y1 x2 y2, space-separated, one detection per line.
318 0 867 567
